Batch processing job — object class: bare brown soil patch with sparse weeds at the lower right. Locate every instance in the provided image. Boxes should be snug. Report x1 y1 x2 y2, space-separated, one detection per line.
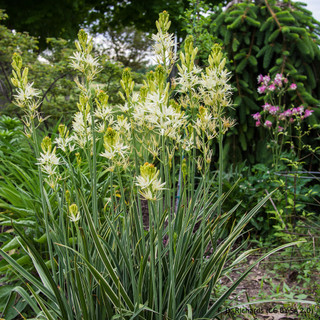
221 254 320 320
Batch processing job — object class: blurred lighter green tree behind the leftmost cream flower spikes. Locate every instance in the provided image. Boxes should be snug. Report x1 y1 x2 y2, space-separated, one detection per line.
0 10 142 125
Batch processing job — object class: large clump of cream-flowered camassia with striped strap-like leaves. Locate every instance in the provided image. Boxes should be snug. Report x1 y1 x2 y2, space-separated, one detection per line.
0 12 304 320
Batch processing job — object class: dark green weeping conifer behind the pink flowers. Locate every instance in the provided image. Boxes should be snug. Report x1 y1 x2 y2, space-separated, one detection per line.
190 0 320 163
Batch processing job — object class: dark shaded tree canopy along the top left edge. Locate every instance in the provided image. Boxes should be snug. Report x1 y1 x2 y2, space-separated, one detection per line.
0 0 227 50
